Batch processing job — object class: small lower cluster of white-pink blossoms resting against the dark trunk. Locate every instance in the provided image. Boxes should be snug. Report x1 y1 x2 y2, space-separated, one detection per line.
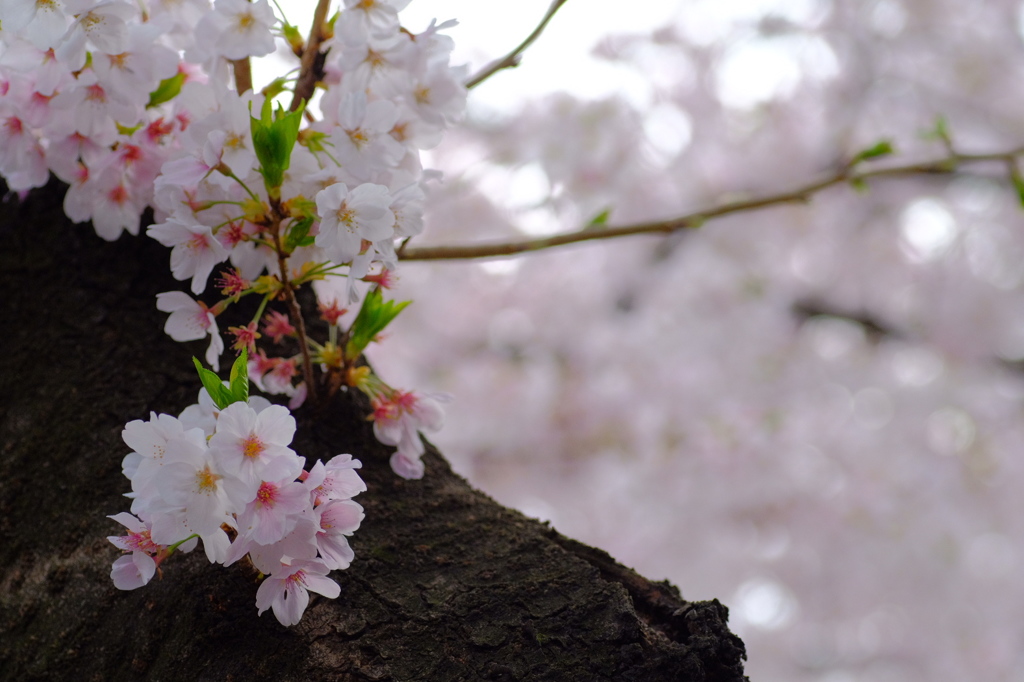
110 378 367 626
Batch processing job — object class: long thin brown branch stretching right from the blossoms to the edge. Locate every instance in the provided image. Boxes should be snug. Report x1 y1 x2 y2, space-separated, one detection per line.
400 146 1024 260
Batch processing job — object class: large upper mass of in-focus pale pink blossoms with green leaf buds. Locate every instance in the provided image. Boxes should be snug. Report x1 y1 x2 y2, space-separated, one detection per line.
0 0 466 477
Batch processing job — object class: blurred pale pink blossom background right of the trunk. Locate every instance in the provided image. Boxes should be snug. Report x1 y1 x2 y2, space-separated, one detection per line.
286 0 1024 682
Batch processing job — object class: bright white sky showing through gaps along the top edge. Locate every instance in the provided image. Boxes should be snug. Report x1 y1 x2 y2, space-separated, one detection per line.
253 0 835 112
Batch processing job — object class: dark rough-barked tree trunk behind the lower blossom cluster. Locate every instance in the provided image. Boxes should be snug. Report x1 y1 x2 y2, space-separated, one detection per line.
0 184 745 682
